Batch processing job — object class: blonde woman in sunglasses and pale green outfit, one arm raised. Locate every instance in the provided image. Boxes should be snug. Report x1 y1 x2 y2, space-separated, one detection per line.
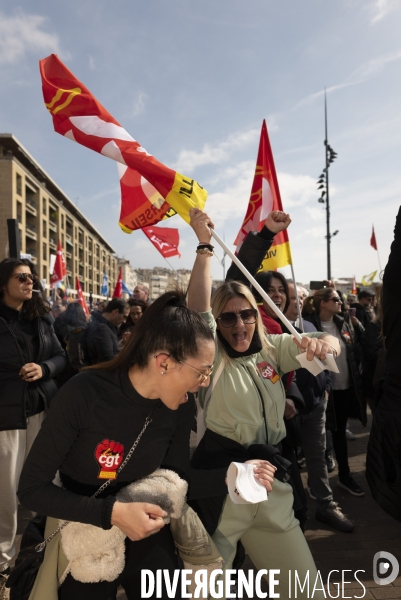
188 209 339 599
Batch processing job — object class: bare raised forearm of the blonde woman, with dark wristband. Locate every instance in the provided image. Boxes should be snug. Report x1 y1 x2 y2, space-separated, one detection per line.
188 208 214 312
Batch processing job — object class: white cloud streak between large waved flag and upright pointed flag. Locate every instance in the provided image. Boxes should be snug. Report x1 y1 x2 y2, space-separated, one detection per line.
173 129 260 173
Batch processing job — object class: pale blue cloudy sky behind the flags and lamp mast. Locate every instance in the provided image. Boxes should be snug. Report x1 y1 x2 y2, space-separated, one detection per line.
0 0 401 282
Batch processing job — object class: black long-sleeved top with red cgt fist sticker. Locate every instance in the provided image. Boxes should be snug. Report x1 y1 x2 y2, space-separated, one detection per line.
18 370 227 526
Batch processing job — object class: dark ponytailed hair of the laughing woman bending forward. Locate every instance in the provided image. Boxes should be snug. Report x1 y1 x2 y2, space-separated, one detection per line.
88 289 213 371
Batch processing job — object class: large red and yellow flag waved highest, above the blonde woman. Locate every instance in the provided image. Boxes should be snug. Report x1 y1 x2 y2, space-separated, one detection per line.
40 54 207 233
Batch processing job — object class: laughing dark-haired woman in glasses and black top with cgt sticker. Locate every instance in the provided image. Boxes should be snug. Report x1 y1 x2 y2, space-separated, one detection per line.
19 291 227 600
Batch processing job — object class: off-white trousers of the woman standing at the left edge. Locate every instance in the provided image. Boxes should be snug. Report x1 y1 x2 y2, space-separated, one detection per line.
0 411 45 571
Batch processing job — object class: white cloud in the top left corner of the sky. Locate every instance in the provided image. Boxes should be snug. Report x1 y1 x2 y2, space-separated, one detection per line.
0 9 66 64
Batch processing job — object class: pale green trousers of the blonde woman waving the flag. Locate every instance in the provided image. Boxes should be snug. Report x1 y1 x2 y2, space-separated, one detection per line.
213 479 325 600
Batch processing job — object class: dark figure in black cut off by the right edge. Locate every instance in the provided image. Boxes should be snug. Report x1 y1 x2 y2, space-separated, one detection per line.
366 208 401 521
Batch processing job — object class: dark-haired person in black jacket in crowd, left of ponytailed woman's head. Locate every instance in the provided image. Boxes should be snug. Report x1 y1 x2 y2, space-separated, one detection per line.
86 298 127 365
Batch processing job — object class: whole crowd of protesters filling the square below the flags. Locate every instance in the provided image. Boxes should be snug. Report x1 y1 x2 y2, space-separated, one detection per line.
0 209 401 600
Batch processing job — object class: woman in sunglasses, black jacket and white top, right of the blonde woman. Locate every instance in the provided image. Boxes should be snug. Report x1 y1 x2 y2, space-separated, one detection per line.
302 287 367 496
